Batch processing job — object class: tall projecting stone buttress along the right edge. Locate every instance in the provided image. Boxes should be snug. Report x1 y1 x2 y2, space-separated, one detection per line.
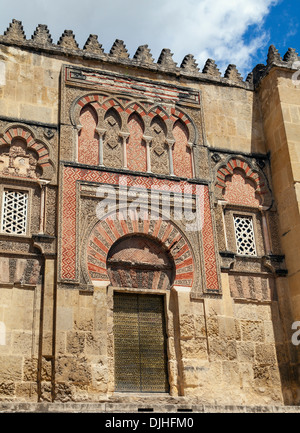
259 69 300 320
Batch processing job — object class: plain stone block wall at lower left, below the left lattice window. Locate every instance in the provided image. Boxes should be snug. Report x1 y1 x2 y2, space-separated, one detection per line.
0 284 41 401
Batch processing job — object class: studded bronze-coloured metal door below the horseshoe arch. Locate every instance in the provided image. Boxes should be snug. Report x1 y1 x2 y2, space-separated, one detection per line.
114 293 169 392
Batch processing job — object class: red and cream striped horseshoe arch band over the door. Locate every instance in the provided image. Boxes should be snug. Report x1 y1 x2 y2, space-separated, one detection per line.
83 210 195 289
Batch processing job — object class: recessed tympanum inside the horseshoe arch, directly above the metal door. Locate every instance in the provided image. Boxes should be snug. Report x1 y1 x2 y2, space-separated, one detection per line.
106 235 175 290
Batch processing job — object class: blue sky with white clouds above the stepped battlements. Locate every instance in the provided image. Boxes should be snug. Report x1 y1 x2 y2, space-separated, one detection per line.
0 0 300 77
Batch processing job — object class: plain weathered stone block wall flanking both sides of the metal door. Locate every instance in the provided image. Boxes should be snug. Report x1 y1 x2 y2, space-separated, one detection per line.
50 281 287 405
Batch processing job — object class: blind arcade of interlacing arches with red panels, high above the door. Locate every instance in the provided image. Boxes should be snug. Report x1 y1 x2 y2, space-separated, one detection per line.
71 95 197 178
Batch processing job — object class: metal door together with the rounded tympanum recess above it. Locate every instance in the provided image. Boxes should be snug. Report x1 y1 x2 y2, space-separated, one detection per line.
106 235 175 392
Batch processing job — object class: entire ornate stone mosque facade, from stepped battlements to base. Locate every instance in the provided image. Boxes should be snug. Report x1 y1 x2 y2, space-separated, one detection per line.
0 20 300 406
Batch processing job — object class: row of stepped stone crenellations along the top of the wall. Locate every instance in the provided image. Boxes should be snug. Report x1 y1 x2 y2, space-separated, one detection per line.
0 19 299 89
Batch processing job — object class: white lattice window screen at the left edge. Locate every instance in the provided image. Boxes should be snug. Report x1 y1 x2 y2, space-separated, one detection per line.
1 190 28 235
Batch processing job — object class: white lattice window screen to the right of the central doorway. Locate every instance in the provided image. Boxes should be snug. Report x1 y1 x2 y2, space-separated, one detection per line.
234 216 256 256
